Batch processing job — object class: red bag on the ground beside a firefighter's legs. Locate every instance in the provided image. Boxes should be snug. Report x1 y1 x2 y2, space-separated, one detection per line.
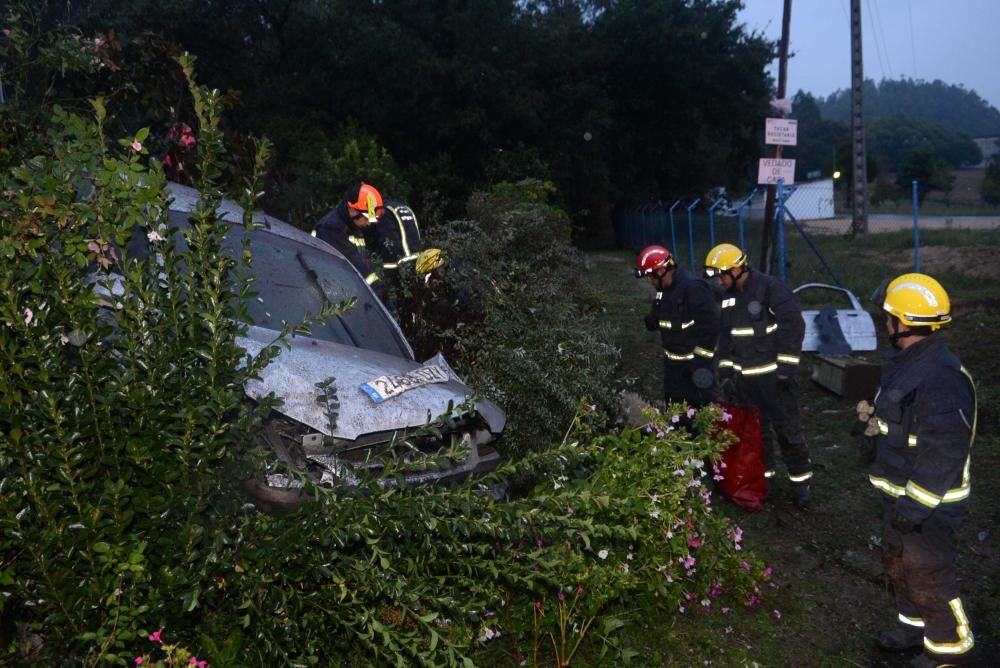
718 401 767 510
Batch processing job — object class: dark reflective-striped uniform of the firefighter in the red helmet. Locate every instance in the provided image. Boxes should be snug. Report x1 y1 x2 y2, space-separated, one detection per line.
647 267 719 408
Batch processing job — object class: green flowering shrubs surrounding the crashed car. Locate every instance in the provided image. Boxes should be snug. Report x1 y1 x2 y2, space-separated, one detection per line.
0 32 763 666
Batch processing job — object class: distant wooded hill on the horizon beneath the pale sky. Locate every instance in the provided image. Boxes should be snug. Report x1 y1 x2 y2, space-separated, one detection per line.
816 79 1000 137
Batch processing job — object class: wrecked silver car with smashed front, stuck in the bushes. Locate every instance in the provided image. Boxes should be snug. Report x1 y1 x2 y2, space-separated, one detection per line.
162 183 506 511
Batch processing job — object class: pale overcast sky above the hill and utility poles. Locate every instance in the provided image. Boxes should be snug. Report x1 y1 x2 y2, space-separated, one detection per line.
740 0 1000 109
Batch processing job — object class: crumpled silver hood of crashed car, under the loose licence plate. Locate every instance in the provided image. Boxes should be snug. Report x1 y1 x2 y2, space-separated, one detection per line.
237 326 507 441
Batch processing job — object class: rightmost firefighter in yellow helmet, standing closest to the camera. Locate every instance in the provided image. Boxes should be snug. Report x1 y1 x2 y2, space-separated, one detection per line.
868 273 976 666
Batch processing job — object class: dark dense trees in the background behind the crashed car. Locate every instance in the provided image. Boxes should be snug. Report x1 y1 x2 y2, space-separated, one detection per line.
1 0 774 239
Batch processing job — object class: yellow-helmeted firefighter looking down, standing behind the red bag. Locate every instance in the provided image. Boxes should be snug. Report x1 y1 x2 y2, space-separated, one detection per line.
705 244 812 509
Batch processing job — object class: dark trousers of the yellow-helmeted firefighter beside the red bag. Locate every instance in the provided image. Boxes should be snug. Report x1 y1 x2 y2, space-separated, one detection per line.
733 373 812 477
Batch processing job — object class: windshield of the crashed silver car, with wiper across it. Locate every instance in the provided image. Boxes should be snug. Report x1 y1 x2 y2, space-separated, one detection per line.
155 211 410 359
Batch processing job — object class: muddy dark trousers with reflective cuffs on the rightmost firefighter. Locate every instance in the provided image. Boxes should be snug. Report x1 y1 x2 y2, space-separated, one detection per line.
882 500 972 660
